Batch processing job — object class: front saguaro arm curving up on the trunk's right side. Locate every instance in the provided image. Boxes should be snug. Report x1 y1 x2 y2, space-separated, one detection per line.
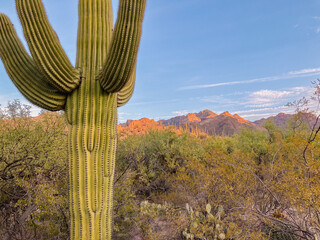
97 0 146 92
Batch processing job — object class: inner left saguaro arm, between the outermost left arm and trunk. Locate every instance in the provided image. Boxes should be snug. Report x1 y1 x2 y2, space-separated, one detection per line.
16 0 80 93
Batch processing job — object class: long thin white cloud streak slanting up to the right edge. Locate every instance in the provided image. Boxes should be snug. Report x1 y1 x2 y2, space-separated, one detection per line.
179 68 320 90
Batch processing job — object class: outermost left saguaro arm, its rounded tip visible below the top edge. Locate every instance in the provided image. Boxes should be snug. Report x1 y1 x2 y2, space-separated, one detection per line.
0 14 66 111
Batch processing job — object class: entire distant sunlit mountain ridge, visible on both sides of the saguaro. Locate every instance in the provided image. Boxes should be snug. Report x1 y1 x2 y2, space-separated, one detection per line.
26 109 320 138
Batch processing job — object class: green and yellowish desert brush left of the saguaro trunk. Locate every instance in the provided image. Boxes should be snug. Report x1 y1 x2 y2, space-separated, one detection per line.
0 101 68 239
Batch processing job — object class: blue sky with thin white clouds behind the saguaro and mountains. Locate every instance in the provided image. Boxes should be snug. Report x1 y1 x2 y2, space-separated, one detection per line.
0 0 320 122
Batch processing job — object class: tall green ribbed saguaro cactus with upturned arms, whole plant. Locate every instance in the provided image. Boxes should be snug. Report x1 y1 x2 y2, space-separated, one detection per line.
0 0 146 240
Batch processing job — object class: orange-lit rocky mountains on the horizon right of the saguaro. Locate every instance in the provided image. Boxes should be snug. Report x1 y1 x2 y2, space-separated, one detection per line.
118 109 316 136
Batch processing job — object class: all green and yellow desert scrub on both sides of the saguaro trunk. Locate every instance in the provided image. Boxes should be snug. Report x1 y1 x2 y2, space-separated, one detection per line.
0 101 320 240
